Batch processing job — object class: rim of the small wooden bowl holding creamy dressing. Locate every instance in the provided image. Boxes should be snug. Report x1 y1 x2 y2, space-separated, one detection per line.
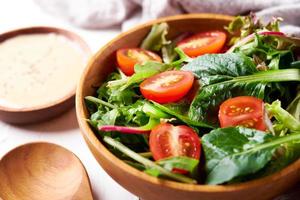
0 26 92 113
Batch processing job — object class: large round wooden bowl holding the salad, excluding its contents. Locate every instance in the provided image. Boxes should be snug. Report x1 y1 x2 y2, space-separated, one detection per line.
76 14 300 200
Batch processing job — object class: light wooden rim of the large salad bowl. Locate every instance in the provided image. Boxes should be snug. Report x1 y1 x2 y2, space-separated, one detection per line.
76 13 300 193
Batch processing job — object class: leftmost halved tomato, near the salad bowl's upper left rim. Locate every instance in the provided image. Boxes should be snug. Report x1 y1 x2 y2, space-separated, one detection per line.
117 48 162 76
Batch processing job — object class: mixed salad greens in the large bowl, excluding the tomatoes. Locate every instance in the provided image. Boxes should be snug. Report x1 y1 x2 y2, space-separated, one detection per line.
85 14 300 185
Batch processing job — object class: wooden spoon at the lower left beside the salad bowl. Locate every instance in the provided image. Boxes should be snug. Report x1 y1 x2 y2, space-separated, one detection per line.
0 142 93 200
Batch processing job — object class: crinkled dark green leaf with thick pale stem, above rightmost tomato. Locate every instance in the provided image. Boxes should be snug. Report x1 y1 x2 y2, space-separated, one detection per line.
182 53 300 123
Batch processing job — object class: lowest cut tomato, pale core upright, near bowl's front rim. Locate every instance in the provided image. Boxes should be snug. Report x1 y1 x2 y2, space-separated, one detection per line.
149 123 201 161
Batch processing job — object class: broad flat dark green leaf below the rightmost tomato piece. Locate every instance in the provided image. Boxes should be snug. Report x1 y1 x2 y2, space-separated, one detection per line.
202 127 300 184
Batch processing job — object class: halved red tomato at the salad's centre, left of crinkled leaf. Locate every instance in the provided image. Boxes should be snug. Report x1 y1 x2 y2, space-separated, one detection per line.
140 70 194 103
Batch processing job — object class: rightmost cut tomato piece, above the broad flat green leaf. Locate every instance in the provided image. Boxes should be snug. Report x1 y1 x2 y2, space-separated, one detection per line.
219 96 267 131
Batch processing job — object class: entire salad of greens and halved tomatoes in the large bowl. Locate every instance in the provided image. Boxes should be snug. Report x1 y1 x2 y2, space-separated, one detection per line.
85 15 300 185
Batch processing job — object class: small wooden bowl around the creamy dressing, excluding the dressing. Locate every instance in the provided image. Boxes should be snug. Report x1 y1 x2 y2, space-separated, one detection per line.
0 26 91 124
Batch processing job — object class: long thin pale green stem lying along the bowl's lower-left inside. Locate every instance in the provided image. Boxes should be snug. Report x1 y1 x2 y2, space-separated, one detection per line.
103 136 197 184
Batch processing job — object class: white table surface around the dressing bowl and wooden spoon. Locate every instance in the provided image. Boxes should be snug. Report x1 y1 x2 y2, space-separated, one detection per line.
0 0 138 200
